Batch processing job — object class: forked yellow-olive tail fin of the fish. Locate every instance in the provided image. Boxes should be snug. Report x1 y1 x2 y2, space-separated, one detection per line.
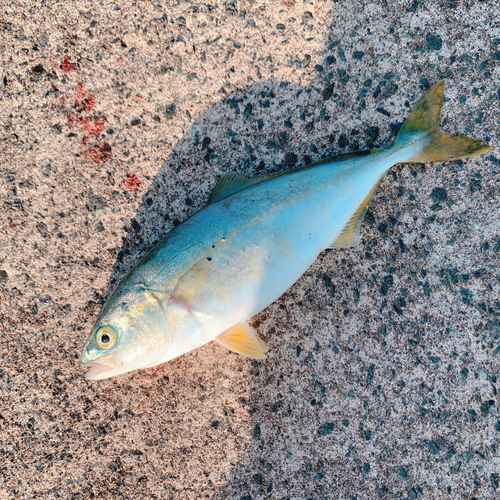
396 80 490 162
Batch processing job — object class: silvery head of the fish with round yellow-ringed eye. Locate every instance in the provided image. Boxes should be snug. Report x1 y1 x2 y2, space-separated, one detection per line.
80 287 170 380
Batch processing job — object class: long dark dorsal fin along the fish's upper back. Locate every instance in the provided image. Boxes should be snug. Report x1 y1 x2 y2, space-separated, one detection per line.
207 149 381 205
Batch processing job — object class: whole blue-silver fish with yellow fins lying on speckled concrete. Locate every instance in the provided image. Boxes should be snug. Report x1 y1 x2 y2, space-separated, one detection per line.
80 81 490 380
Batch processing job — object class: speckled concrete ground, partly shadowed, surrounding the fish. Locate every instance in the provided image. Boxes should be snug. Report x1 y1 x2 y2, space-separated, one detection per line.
0 0 500 500
